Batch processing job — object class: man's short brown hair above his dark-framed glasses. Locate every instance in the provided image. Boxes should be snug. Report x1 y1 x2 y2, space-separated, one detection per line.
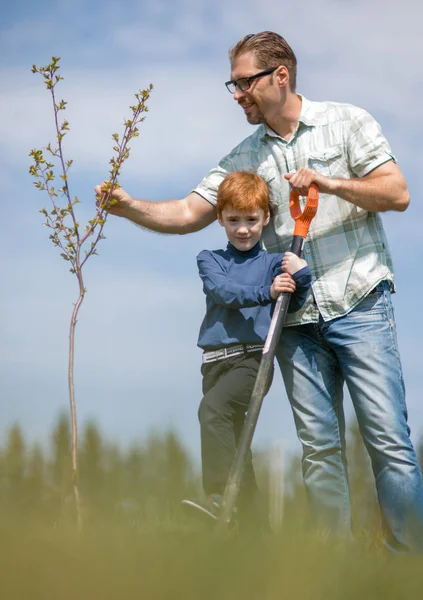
229 31 297 92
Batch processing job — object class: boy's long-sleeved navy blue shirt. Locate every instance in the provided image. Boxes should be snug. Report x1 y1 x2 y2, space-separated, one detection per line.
197 242 311 350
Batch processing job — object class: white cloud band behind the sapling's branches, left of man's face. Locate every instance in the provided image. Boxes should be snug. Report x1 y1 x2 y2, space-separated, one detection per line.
0 64 248 184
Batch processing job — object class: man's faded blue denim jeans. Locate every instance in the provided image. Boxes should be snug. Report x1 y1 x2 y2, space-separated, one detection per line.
277 282 423 552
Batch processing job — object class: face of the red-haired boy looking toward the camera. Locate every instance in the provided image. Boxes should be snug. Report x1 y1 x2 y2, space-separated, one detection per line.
219 207 270 251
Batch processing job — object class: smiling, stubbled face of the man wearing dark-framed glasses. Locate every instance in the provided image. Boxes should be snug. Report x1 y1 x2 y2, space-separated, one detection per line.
231 53 280 125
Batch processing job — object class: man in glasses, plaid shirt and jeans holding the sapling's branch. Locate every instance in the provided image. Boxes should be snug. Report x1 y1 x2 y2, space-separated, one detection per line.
96 32 423 551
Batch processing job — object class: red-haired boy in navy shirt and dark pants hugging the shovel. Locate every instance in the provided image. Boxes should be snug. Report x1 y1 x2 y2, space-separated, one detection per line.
183 171 311 521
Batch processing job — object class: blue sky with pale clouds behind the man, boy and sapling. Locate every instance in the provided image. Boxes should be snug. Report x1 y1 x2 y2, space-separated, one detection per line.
0 0 423 464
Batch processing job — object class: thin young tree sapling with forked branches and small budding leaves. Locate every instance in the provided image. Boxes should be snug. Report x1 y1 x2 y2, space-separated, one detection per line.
29 56 153 529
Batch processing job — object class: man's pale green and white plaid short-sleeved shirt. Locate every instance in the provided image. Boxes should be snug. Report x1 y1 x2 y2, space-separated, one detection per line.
194 97 395 325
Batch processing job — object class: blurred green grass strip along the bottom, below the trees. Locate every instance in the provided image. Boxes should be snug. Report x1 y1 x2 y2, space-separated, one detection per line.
0 519 423 600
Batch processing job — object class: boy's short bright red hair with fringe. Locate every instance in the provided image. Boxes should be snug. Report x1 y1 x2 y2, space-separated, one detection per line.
216 171 270 219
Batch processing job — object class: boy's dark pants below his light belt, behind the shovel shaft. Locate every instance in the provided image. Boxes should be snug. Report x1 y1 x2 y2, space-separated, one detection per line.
198 351 272 518
